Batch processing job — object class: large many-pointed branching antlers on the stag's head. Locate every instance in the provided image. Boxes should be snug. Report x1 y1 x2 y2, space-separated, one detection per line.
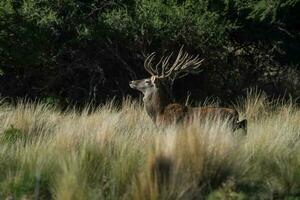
144 47 204 80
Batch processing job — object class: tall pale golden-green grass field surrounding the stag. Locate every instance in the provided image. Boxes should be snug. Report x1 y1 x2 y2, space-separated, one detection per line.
0 93 300 200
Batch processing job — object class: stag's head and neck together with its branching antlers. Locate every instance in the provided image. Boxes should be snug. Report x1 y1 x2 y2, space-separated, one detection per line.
129 48 203 123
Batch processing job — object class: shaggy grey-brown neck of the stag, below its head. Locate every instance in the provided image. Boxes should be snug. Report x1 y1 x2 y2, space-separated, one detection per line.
143 88 173 122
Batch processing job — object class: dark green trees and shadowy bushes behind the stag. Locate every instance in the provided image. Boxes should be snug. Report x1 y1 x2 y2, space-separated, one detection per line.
0 0 300 105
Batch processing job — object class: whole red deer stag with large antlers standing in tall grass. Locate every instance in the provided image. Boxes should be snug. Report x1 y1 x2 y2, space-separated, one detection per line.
129 48 247 130
